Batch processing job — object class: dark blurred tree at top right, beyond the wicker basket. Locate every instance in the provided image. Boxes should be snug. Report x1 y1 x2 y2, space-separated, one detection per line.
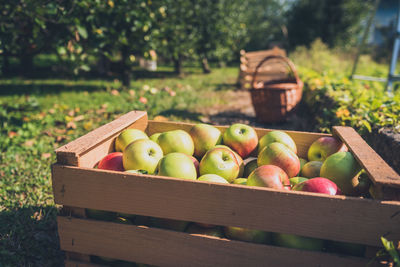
287 0 372 48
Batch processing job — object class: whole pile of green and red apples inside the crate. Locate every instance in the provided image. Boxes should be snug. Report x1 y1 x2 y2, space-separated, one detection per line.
94 124 369 255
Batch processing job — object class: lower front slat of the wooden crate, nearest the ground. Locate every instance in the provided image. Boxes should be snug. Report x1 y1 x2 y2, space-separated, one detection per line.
57 217 376 267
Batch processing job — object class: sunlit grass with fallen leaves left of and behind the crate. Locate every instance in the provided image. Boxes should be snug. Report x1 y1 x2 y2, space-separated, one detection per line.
0 68 237 266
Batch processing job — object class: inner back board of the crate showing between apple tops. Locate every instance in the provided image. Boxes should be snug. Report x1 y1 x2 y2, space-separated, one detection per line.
147 120 331 159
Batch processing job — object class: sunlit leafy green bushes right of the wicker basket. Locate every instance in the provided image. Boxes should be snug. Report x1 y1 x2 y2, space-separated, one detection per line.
291 41 400 133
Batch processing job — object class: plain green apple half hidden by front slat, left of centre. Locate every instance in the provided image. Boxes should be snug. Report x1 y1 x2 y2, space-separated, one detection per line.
158 152 197 180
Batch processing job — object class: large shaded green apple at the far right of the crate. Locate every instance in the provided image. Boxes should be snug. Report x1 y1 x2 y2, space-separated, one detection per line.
320 152 361 195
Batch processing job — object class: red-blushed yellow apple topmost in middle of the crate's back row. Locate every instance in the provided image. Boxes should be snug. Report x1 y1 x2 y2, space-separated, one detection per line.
222 123 258 158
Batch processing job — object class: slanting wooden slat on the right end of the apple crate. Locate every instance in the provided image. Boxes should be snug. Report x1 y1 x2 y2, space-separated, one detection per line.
333 126 400 190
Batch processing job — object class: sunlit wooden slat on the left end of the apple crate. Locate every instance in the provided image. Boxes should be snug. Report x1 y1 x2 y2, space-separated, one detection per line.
56 111 147 167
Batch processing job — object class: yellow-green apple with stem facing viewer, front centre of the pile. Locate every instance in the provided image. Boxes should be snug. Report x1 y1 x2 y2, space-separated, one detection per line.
200 147 240 183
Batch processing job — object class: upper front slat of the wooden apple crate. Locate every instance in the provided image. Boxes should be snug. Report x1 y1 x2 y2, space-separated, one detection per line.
52 165 400 246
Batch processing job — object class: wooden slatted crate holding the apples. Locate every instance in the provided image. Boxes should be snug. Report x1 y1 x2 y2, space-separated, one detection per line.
52 111 400 266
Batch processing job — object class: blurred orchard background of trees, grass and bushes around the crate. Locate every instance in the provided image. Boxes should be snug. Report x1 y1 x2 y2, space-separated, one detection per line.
0 0 400 266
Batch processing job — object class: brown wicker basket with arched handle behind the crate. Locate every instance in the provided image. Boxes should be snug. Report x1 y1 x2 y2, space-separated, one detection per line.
250 55 303 122
